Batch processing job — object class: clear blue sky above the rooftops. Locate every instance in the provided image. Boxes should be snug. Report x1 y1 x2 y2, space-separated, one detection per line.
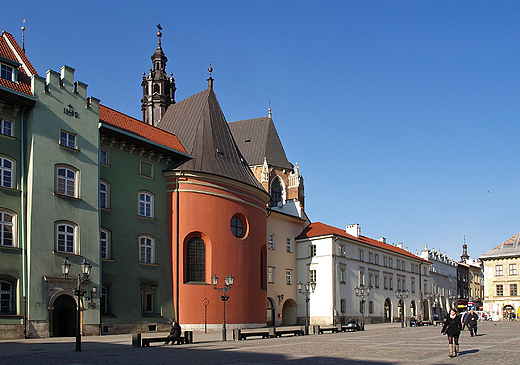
8 0 520 260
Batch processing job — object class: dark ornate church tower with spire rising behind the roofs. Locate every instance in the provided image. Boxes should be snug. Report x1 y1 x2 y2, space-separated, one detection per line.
141 24 176 126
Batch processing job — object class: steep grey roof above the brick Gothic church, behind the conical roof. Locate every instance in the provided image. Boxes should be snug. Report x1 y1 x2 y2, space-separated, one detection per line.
229 117 293 170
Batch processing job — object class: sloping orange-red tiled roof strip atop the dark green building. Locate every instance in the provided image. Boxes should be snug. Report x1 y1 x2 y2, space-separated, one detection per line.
99 105 186 154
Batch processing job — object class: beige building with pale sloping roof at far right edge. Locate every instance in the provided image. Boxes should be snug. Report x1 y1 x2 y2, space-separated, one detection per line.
480 233 520 320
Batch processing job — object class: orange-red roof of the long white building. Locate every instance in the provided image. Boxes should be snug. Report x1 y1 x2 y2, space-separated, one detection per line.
296 222 429 262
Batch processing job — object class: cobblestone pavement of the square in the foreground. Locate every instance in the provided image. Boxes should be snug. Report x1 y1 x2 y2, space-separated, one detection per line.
0 321 520 365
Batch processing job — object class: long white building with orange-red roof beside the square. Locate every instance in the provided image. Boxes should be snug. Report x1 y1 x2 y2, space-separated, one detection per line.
296 222 431 325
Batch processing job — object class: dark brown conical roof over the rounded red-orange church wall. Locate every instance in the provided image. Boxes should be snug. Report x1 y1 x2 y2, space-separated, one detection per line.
157 88 265 191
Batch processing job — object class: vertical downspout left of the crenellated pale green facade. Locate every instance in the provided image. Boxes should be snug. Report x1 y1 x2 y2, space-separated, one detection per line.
20 107 27 338
